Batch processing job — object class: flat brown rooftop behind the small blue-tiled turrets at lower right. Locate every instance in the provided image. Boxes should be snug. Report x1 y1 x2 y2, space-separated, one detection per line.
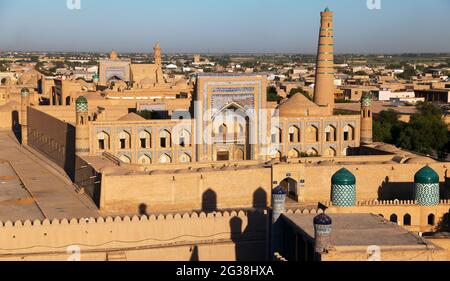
282 214 436 248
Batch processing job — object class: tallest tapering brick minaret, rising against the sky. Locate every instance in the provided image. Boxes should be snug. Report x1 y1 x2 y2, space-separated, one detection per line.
314 8 335 114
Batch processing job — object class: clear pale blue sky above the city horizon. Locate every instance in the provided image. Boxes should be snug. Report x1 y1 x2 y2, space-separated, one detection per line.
0 0 450 54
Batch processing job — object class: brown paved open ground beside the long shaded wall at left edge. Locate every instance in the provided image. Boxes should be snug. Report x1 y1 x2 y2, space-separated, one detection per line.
0 131 99 221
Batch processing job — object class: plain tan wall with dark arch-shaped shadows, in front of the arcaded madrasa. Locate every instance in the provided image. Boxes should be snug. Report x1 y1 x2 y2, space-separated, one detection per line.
100 168 271 213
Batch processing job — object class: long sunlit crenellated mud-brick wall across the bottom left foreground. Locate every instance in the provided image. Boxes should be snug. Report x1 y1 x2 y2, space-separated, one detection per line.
0 208 268 261
